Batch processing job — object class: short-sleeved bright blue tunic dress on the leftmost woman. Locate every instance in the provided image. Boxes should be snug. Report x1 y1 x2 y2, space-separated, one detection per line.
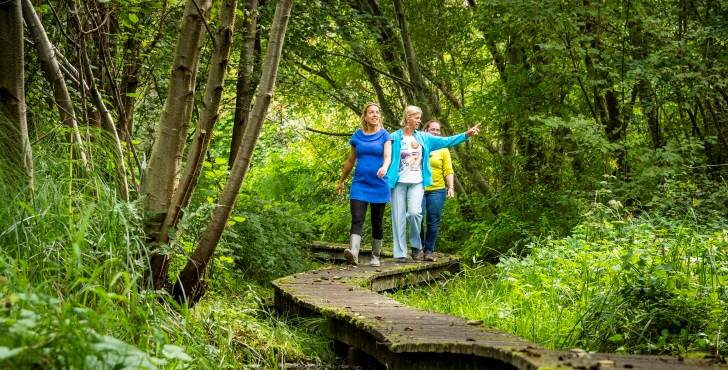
349 129 389 203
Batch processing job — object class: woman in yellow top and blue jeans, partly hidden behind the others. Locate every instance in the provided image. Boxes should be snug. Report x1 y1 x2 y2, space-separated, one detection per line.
420 120 455 261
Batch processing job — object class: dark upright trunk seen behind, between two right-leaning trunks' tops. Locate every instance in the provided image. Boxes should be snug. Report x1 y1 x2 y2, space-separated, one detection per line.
228 0 258 167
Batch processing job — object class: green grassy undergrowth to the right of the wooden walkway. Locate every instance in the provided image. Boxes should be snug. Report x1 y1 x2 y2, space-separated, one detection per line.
395 203 728 357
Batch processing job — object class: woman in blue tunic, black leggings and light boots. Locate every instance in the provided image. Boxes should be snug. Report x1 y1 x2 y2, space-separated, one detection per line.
337 103 392 266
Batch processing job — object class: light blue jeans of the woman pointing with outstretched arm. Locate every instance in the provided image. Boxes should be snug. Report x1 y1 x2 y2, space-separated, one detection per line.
391 182 425 258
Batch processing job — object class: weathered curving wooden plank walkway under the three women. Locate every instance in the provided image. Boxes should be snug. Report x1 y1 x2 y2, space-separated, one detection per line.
273 243 728 370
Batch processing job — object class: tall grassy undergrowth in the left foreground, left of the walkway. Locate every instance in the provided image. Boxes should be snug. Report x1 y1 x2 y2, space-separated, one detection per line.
0 137 333 369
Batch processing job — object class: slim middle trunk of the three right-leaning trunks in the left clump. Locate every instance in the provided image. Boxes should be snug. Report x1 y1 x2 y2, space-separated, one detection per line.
159 0 237 249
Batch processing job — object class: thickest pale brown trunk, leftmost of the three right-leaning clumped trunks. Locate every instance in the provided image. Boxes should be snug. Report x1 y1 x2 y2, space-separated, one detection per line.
142 0 212 289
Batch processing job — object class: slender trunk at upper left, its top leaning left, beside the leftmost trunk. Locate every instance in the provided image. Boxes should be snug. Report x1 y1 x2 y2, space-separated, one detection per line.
21 0 88 167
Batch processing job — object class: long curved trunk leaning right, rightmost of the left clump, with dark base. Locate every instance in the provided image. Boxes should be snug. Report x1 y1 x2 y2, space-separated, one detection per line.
172 0 293 306
